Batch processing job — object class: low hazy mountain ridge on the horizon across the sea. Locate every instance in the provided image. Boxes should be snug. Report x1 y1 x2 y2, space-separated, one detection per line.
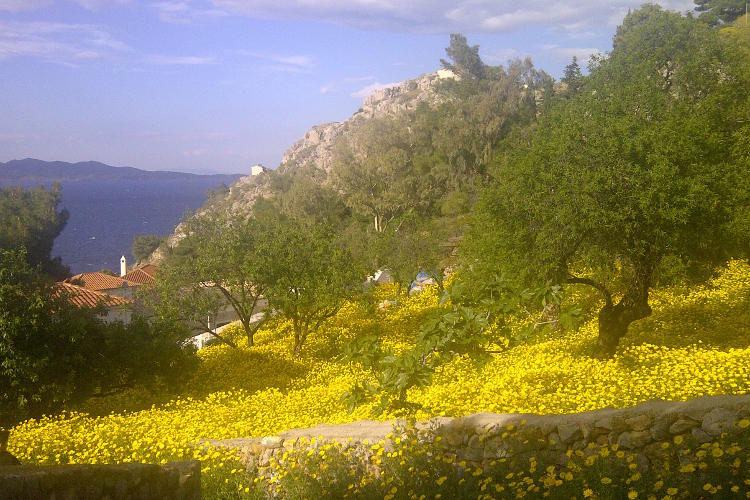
0 158 242 186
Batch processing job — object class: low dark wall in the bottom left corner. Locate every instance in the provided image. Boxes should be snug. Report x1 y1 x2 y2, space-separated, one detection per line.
0 461 201 500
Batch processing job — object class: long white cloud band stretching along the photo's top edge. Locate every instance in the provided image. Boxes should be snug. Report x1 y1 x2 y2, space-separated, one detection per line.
212 0 693 32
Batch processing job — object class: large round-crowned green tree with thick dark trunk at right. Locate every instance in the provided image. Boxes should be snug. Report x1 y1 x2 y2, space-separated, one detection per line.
466 6 747 354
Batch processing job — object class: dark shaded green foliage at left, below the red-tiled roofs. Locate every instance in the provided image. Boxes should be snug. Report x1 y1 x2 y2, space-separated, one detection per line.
0 250 191 425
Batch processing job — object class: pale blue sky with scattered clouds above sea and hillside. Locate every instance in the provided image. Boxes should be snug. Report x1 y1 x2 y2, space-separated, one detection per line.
0 0 693 174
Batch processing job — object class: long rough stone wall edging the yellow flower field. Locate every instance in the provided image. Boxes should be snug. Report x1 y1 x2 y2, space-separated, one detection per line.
208 395 750 470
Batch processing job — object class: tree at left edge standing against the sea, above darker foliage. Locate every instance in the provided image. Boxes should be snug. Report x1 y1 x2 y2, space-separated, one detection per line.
0 184 70 278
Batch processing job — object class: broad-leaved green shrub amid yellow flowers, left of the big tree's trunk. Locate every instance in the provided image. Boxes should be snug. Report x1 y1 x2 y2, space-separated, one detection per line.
342 276 580 416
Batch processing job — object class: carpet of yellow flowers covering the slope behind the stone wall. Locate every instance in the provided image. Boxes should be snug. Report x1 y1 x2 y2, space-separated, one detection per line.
9 261 750 498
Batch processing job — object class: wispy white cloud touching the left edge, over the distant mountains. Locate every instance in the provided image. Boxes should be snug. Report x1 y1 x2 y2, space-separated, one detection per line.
0 21 130 65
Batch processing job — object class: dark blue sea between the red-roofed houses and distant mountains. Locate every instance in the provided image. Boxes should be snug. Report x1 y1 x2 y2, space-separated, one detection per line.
52 178 223 274
